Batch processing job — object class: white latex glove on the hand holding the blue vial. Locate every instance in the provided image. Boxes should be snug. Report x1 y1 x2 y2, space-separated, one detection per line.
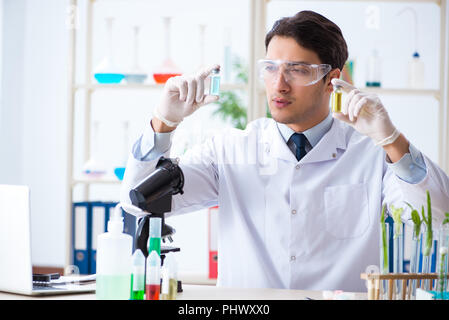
153 65 220 127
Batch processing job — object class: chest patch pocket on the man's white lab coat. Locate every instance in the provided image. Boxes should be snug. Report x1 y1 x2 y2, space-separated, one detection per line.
324 183 370 239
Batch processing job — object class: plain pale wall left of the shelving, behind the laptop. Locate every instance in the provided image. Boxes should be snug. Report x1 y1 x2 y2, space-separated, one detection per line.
0 0 67 265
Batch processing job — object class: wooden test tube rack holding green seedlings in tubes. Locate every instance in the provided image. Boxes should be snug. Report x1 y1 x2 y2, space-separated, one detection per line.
360 273 449 300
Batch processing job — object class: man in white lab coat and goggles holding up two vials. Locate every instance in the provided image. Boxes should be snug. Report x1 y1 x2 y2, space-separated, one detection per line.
122 11 449 291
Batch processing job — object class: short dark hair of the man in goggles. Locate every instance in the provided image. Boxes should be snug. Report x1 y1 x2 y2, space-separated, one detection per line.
265 11 348 70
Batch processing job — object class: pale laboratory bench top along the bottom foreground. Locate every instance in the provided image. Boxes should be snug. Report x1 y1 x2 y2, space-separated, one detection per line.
0 284 367 300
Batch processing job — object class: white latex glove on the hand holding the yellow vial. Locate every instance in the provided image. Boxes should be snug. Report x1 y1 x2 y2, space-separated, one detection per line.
332 78 400 146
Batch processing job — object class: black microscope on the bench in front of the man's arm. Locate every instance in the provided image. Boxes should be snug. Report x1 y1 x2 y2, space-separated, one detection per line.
125 157 184 292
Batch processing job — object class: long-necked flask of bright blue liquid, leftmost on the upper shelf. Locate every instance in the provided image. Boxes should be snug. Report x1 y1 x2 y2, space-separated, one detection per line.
94 17 125 84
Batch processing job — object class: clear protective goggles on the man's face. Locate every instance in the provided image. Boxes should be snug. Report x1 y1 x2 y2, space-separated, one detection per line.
257 60 332 86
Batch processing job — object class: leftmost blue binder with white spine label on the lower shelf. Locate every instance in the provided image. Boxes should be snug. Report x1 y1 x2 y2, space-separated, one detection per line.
72 202 92 274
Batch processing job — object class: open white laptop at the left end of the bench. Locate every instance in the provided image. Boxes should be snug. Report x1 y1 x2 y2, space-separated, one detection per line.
0 185 95 295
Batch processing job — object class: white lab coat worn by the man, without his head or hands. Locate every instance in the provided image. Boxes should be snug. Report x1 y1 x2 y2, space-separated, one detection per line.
122 118 449 292
